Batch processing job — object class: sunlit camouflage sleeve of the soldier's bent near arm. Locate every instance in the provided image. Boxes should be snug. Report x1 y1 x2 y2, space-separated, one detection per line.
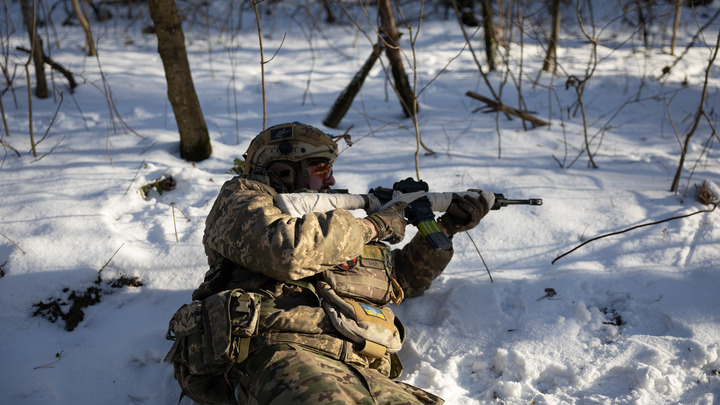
203 177 370 281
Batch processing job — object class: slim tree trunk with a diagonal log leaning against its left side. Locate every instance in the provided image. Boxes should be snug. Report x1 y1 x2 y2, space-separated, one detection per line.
377 0 415 117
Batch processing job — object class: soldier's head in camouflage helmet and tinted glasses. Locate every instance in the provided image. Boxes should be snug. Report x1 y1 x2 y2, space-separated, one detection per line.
243 122 351 192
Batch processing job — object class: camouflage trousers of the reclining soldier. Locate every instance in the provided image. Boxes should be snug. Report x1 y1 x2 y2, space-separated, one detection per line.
237 349 444 405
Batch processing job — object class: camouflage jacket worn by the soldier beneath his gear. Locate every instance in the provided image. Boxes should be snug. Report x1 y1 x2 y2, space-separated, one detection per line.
200 176 453 374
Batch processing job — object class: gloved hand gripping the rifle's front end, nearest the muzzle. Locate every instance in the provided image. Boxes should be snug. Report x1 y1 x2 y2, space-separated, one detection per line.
438 190 495 235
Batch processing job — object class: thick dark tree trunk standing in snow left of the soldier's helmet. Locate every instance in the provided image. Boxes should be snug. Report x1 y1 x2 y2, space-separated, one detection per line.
148 0 212 162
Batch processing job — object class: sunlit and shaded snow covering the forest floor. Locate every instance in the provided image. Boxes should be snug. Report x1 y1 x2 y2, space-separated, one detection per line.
0 0 720 405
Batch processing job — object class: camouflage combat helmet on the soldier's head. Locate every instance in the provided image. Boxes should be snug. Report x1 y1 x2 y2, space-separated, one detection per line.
243 122 352 192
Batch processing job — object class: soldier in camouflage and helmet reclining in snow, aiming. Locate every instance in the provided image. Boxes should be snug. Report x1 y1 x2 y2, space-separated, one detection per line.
169 122 493 405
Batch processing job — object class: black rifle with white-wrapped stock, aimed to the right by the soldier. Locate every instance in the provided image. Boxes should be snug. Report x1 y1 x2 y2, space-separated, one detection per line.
275 178 542 250
